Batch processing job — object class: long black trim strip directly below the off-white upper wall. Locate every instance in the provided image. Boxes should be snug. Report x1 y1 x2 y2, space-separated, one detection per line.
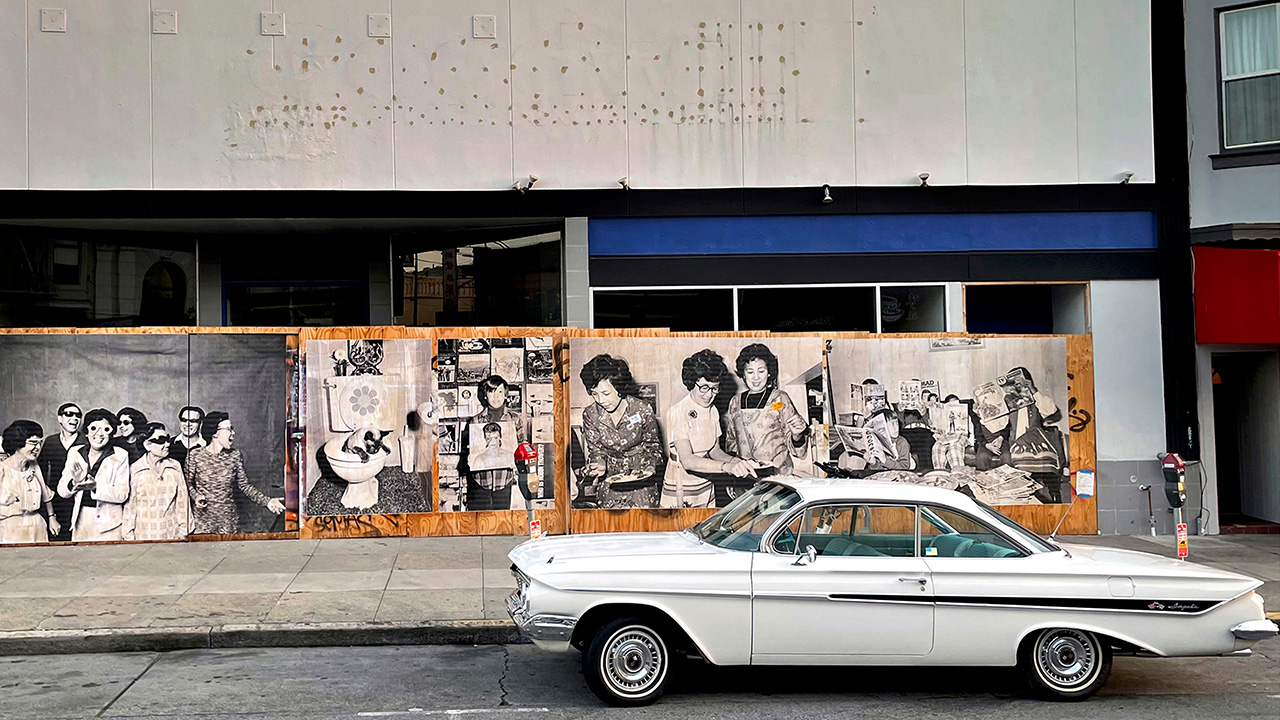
0 181 1187 220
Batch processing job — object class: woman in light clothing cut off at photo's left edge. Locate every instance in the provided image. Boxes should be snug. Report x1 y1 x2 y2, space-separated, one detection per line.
0 420 58 543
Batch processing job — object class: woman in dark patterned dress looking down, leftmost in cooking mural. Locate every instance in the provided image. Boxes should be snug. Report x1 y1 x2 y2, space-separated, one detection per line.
579 355 664 507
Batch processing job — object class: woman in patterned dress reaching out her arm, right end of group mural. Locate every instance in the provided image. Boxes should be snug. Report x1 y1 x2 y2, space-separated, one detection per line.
187 413 284 534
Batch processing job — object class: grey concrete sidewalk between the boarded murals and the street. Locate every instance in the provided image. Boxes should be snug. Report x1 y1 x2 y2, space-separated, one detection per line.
0 536 1280 655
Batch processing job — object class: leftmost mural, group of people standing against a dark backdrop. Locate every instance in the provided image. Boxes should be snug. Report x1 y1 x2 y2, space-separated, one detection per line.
0 334 288 543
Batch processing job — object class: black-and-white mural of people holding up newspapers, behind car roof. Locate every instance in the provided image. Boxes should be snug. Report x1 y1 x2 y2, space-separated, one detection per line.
827 338 1071 505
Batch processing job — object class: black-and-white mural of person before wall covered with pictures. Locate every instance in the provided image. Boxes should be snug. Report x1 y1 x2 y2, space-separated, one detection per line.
435 337 556 511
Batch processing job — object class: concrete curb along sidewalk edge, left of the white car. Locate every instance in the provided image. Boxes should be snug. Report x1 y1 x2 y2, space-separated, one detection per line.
0 620 527 655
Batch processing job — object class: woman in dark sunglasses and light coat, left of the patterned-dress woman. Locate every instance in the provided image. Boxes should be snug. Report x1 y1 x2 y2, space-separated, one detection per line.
125 423 188 539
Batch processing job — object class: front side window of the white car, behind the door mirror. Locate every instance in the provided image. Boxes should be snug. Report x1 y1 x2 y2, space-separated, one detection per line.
796 505 915 557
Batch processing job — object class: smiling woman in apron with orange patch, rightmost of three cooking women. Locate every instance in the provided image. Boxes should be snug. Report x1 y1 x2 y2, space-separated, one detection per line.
724 342 809 475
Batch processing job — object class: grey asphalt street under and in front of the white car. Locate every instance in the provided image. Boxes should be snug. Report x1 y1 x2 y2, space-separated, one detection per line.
0 639 1280 720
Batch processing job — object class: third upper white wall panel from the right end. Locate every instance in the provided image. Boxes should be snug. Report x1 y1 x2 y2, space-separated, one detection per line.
854 0 968 184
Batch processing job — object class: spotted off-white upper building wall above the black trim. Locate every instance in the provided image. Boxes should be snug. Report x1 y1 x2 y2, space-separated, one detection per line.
0 0 1153 190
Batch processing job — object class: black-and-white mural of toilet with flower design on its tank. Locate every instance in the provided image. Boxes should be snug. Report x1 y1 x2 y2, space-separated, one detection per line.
302 338 436 518
